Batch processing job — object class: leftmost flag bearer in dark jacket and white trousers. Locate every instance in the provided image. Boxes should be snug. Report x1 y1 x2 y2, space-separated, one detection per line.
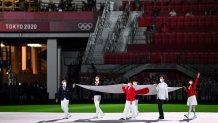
56 80 72 119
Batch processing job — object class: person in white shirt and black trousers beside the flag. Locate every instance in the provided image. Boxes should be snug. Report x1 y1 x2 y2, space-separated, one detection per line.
155 75 169 119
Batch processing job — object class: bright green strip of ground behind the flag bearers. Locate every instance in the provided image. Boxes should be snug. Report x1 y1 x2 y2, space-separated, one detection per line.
0 104 218 113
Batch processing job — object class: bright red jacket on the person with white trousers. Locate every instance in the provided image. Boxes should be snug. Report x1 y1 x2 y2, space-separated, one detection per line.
122 86 136 101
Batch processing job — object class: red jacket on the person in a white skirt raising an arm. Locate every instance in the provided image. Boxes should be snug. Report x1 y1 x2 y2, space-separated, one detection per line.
184 77 199 97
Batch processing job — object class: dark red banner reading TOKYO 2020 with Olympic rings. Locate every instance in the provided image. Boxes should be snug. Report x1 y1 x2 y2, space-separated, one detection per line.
0 12 100 32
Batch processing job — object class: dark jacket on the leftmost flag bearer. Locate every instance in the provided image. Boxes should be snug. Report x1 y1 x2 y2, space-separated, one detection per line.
58 85 72 100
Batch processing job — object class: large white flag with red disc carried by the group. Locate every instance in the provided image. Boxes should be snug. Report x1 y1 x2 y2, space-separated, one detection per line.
76 84 182 95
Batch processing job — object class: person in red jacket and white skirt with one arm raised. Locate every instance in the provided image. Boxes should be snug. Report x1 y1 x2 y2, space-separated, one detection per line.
183 73 200 119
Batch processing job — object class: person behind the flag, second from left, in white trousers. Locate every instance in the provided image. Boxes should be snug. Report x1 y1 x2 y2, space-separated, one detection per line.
93 76 104 118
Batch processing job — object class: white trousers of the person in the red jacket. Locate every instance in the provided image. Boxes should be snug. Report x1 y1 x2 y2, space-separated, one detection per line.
123 101 137 119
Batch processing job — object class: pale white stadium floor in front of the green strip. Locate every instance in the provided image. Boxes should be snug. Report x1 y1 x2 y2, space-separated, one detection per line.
0 112 218 123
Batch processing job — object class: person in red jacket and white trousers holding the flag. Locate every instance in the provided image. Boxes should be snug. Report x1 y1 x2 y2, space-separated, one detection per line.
120 81 137 120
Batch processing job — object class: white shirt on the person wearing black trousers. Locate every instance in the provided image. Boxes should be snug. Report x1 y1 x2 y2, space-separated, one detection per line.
156 82 168 100
